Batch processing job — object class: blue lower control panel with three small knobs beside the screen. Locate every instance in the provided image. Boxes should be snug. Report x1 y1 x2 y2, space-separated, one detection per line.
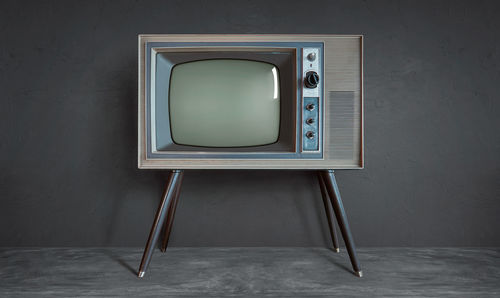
302 97 320 151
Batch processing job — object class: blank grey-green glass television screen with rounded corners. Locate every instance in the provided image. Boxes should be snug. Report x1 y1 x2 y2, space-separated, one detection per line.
169 59 280 147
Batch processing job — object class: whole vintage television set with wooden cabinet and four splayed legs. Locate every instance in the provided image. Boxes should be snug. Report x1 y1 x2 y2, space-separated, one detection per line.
138 34 364 276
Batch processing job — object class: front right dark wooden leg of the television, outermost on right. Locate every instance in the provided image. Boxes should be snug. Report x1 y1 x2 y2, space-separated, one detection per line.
323 170 363 277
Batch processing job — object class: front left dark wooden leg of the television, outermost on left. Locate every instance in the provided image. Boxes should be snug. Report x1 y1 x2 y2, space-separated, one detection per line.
137 170 182 277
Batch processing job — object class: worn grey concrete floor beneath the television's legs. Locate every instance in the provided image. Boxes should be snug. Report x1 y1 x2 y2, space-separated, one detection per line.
0 248 500 297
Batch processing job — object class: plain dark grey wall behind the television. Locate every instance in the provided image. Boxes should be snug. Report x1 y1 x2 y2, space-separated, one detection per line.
0 0 500 246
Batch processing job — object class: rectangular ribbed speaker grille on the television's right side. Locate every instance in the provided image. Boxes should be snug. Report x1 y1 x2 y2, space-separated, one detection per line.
327 91 360 164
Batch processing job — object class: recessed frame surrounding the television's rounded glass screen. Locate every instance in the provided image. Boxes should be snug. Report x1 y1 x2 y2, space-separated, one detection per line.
151 48 297 153
